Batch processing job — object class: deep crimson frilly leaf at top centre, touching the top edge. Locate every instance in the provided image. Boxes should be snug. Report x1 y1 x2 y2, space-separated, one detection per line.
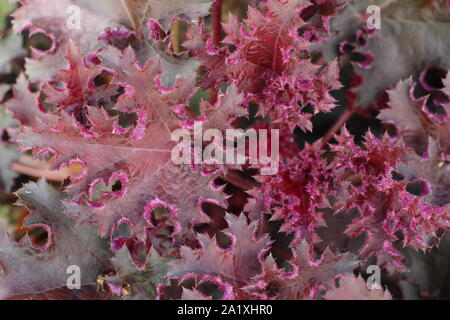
185 0 341 130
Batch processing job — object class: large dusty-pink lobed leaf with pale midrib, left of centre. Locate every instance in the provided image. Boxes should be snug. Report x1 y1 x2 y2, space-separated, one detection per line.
18 43 234 241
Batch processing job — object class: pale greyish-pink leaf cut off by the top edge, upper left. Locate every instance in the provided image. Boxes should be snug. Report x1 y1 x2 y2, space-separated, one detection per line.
13 0 122 81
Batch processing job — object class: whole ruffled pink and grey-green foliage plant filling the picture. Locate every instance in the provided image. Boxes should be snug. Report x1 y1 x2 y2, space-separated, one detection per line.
0 0 450 299
